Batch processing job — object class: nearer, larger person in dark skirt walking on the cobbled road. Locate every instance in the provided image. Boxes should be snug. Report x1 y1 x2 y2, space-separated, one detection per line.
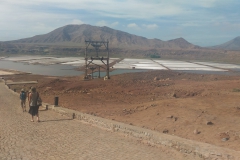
28 87 40 122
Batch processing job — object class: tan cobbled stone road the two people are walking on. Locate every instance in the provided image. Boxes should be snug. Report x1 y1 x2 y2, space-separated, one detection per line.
0 81 199 160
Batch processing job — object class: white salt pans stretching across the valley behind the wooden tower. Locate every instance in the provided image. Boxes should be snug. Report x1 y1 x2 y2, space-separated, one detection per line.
1 56 240 71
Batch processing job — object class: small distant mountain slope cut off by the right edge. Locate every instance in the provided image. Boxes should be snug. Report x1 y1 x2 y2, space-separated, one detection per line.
211 36 240 50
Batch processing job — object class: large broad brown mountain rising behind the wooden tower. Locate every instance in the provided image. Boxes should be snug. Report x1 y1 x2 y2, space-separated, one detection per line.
8 24 200 49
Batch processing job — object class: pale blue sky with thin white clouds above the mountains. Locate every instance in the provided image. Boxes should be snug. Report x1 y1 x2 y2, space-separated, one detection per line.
0 0 240 47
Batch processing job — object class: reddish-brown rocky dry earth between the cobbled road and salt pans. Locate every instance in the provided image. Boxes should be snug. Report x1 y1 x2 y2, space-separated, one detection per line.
3 71 240 151
